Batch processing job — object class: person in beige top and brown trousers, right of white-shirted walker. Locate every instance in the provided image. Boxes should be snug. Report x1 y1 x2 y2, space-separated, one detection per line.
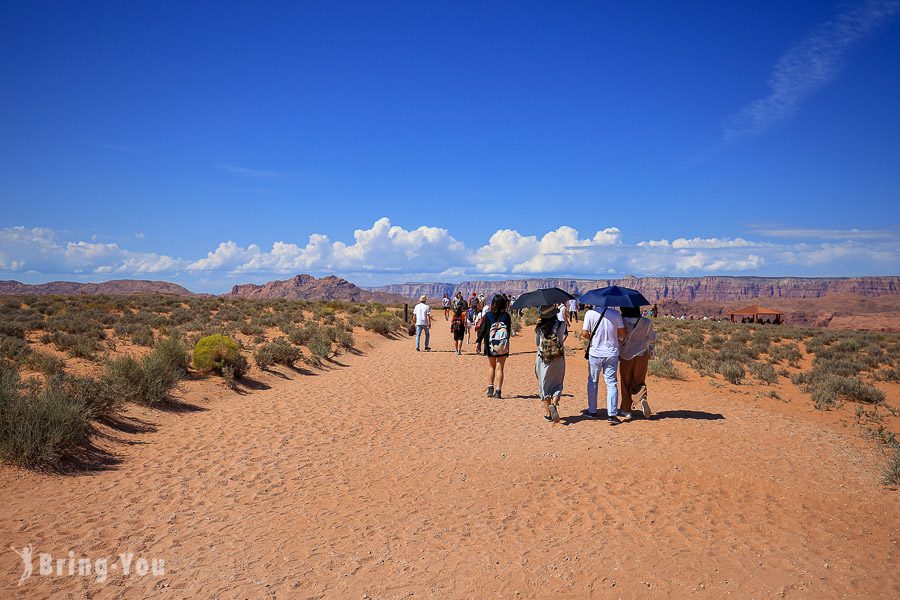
619 306 656 421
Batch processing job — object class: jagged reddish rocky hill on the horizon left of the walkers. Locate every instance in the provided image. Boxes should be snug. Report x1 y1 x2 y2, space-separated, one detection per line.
227 275 404 304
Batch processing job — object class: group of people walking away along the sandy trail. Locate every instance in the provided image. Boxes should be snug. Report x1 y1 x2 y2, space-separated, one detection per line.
413 292 656 425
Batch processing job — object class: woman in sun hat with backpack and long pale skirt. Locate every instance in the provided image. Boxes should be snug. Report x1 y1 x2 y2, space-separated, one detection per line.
534 305 568 423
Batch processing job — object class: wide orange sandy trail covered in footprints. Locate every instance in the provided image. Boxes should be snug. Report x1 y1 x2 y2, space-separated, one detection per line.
0 316 900 598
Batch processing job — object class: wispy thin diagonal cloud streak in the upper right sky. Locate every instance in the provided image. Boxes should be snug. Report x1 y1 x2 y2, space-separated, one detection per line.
724 0 900 142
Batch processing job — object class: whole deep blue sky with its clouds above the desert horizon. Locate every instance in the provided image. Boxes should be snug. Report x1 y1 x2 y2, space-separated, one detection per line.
0 0 900 291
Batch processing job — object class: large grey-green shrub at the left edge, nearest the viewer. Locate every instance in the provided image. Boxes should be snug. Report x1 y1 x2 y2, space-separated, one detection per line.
0 369 92 468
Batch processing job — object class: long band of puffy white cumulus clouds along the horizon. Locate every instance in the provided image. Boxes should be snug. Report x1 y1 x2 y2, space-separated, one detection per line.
0 217 900 283
